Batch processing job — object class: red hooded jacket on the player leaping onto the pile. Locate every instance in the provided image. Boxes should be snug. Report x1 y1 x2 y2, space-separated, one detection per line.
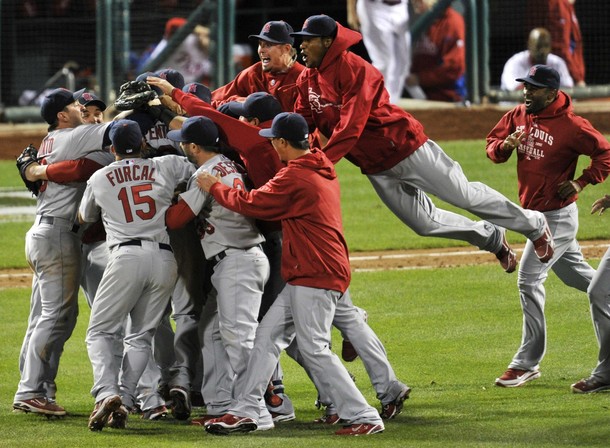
294 23 428 174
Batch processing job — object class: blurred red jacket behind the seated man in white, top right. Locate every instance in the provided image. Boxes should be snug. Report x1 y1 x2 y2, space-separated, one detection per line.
527 0 585 84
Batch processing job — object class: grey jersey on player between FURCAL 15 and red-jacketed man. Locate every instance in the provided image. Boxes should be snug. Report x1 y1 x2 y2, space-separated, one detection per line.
180 154 265 259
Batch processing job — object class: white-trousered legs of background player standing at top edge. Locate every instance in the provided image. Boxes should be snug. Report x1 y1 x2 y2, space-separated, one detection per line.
347 0 411 103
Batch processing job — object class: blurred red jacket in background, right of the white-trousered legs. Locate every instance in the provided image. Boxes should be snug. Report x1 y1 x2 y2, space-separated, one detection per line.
411 7 466 101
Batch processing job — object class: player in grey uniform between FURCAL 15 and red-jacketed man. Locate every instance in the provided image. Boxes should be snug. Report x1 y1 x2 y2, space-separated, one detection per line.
167 116 273 427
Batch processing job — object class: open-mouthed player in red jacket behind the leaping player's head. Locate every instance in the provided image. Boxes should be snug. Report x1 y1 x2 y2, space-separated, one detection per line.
210 20 305 111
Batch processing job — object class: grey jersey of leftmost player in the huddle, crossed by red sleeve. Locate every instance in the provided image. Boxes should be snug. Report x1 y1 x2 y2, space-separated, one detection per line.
36 123 108 221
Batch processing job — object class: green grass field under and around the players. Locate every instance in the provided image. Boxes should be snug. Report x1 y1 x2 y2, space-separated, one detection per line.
0 141 610 448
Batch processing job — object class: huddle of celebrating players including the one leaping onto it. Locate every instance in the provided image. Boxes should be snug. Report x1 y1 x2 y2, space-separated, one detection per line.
13 15 610 435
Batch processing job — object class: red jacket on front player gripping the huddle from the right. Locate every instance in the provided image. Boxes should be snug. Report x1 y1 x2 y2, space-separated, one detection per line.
210 149 351 292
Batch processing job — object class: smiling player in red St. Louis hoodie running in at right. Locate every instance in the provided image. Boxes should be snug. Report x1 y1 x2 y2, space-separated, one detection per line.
487 65 610 392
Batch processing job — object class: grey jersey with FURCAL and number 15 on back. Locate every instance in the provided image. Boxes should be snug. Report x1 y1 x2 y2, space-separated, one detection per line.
79 155 195 248
